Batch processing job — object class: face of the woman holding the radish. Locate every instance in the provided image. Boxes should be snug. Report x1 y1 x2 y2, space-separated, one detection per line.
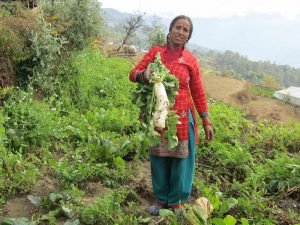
170 19 191 48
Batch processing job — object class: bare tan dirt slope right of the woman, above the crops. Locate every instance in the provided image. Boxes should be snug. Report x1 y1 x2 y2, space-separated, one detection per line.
203 75 300 123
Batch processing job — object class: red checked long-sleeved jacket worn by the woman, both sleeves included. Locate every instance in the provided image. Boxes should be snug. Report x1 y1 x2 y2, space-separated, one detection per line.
129 45 208 143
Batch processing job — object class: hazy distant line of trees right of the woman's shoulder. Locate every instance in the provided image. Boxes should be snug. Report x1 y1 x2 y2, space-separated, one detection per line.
193 48 300 87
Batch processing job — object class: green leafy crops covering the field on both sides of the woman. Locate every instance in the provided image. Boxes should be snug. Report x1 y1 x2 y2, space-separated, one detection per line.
0 48 300 224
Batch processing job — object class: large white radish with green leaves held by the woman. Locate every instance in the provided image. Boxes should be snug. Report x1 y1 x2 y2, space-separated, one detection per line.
133 53 179 149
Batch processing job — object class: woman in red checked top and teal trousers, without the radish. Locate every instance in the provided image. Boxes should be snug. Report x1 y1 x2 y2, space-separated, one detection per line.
129 15 214 215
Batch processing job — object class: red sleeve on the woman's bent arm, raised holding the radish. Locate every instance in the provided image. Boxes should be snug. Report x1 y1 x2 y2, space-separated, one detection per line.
129 47 157 82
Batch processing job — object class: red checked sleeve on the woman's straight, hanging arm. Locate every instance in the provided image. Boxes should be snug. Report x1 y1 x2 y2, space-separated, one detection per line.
190 58 208 116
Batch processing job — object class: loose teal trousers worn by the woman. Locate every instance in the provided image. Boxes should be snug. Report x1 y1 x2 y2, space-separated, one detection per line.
150 110 196 206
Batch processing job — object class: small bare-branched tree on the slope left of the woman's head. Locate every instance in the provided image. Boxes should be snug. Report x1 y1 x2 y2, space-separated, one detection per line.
117 13 145 52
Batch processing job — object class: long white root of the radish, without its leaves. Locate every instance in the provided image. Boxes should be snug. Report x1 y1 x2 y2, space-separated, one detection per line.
153 82 169 130
